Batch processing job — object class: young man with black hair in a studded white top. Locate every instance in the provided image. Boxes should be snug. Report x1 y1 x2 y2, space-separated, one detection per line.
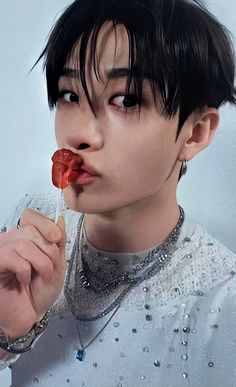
0 0 236 387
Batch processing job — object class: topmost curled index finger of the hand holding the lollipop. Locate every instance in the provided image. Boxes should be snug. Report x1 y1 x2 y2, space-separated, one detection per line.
20 208 62 243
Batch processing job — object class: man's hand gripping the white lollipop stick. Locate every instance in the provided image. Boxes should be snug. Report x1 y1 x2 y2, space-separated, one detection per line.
0 209 66 338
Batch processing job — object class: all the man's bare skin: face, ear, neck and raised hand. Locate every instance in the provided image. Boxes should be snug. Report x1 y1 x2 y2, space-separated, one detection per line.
0 23 219 346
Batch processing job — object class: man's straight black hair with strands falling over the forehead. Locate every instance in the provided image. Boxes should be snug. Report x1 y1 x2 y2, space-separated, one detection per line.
37 0 236 139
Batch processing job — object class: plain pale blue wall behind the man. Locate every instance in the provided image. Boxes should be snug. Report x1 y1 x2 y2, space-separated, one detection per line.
0 0 236 387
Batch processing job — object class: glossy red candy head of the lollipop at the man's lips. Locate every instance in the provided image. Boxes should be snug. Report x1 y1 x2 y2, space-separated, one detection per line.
52 149 82 189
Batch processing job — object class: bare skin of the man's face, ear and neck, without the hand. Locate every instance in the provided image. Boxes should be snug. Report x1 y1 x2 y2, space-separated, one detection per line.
56 23 219 252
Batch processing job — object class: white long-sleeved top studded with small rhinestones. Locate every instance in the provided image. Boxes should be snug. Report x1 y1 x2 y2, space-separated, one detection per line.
1 196 236 387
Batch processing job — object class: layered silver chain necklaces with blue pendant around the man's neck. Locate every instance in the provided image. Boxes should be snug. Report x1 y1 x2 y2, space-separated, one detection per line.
64 206 185 361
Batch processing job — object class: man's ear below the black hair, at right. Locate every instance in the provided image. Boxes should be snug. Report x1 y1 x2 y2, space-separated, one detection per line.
179 108 220 161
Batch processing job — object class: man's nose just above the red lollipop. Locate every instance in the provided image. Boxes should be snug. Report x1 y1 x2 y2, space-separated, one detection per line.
57 110 104 151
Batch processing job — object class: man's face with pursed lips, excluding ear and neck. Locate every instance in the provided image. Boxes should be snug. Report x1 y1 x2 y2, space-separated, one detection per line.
55 24 189 213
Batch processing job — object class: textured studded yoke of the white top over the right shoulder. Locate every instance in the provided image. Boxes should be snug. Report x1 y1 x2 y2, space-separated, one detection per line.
126 217 236 305
